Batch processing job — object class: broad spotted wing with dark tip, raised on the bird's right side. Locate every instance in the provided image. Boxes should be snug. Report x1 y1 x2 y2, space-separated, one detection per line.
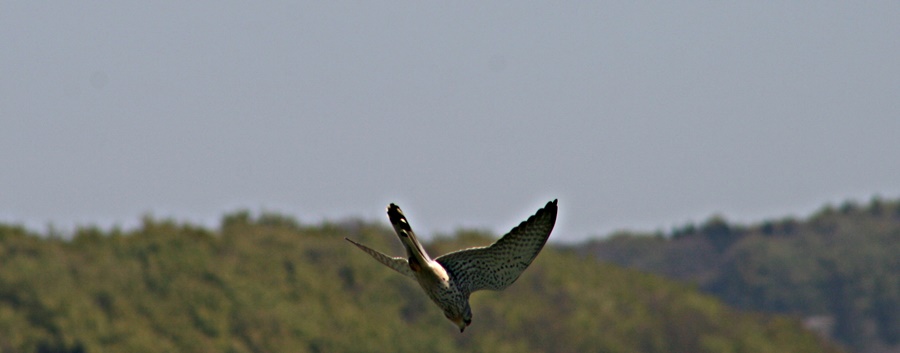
435 200 557 294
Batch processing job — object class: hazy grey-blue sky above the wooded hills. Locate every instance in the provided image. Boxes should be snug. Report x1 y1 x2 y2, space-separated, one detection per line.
0 1 900 240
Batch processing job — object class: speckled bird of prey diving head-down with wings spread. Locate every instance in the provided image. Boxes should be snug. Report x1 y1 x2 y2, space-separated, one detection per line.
344 200 557 332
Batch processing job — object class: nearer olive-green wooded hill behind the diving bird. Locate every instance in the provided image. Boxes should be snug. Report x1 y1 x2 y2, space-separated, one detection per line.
0 213 840 353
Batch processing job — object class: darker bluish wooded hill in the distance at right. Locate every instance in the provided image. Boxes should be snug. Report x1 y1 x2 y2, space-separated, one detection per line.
573 198 900 353
